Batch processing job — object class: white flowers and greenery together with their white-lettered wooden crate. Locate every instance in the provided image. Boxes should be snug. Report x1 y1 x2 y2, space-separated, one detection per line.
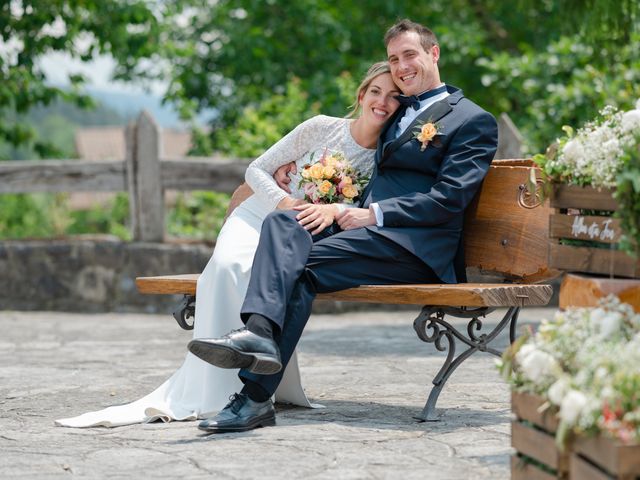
534 101 640 277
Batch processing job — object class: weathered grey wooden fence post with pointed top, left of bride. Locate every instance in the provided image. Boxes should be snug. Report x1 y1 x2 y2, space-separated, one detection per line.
126 111 164 242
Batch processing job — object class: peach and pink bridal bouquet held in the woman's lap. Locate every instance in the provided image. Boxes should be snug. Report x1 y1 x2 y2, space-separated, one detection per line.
299 149 369 204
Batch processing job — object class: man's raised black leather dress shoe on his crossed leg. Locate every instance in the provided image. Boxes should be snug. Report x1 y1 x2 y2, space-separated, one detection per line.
189 328 282 375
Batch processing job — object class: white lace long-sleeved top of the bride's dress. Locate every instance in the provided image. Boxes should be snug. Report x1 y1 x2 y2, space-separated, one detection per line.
245 115 375 210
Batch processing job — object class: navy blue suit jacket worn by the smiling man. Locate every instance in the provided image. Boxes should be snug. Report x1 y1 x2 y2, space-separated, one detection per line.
361 86 498 283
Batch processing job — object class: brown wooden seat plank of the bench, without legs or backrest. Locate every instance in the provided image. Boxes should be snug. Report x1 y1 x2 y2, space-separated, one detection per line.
136 274 553 307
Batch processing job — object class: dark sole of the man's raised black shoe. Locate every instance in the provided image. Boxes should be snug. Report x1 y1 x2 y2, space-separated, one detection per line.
189 340 282 375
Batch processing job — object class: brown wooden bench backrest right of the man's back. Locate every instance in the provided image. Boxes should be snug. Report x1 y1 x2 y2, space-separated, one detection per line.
464 160 556 283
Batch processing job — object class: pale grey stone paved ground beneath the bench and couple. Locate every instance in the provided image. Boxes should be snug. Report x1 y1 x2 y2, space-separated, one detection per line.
0 309 552 480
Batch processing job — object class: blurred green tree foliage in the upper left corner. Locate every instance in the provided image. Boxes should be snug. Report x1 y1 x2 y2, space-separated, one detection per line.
0 0 161 157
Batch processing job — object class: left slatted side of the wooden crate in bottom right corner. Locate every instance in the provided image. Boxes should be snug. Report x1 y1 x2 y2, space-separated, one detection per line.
511 392 571 480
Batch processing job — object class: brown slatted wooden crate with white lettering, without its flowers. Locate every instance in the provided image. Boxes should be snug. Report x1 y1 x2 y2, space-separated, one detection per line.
549 183 640 278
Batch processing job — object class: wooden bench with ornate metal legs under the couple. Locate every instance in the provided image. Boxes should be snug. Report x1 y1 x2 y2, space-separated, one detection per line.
136 160 555 421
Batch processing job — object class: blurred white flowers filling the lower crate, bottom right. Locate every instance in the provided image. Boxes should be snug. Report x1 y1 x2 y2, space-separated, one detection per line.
499 295 640 444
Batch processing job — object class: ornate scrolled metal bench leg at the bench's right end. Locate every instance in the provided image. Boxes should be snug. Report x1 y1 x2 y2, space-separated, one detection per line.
413 306 520 422
